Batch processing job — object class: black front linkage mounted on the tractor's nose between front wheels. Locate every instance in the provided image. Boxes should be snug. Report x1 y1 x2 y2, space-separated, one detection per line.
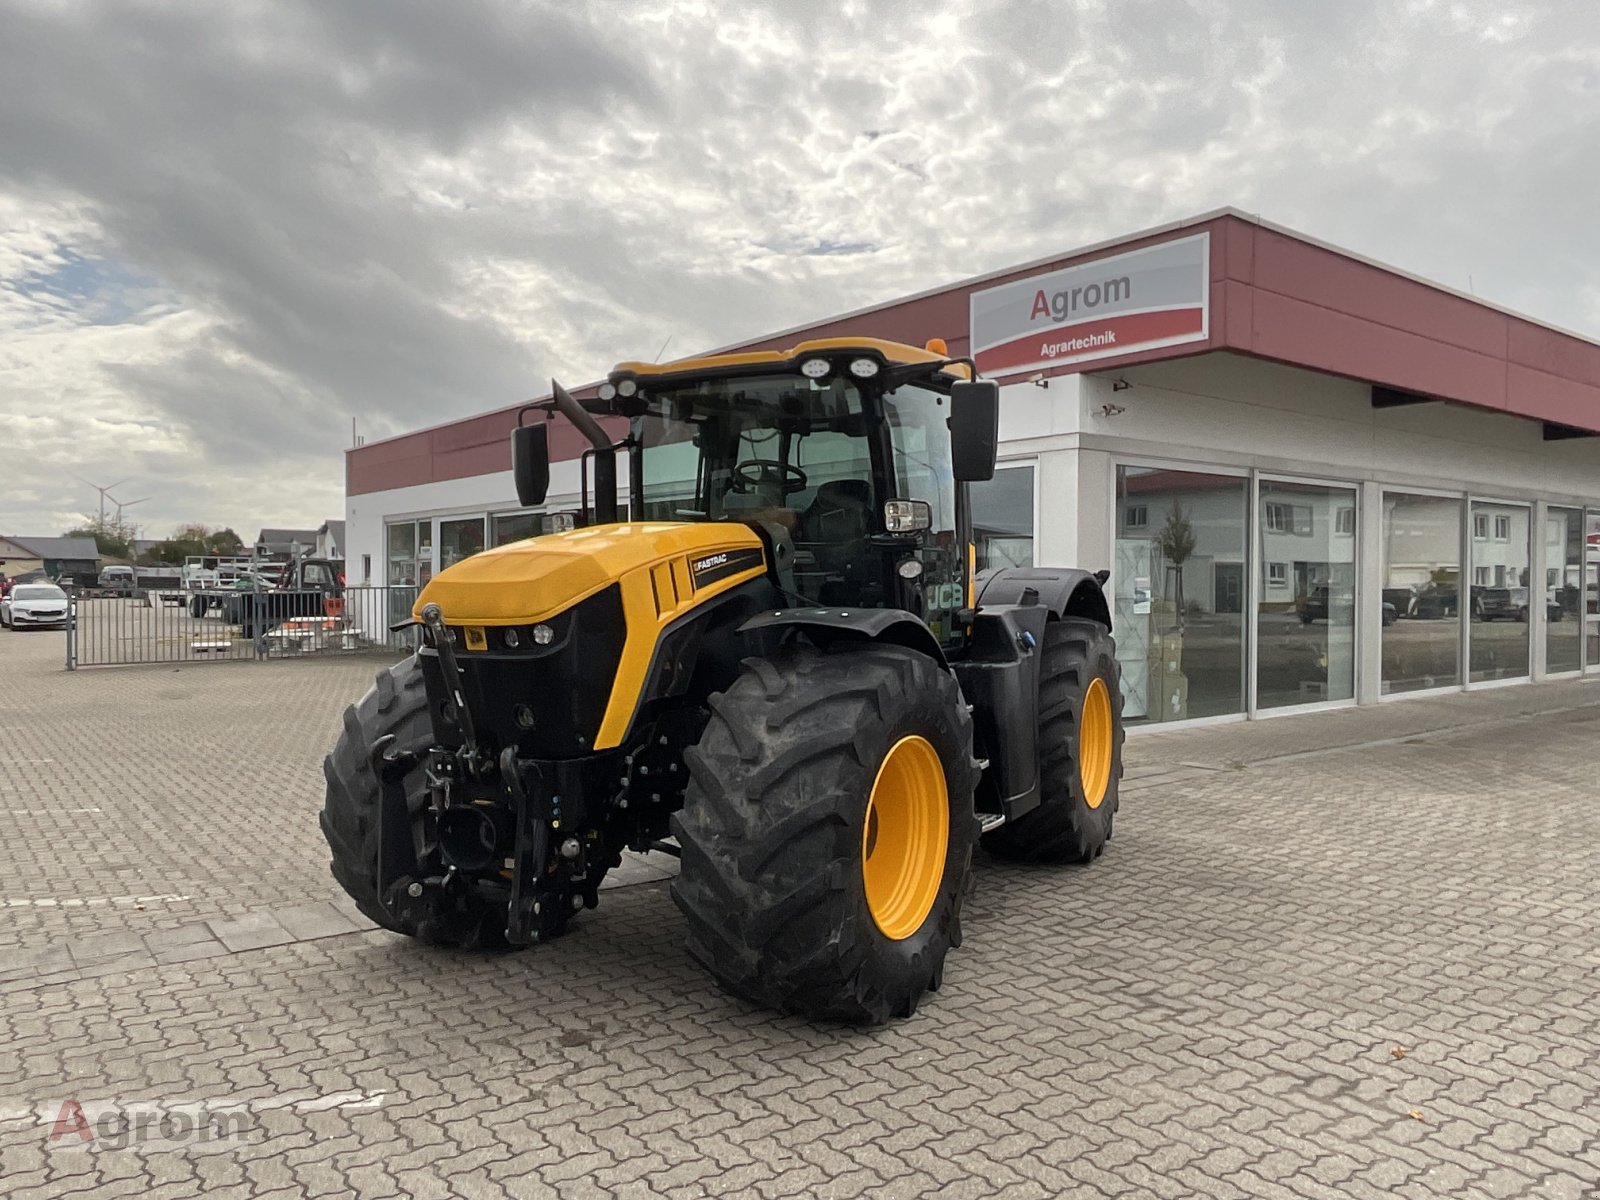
371 605 604 946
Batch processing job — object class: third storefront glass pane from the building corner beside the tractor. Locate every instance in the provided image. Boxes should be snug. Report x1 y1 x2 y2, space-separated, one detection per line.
1382 491 1462 693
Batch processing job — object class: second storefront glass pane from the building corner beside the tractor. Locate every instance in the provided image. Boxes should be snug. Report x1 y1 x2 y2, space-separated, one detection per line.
1256 480 1357 709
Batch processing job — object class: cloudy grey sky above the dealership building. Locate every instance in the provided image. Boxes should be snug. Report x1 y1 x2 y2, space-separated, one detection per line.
0 0 1600 538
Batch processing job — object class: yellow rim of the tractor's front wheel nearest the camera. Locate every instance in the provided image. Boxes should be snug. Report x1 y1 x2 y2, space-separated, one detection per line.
861 734 950 941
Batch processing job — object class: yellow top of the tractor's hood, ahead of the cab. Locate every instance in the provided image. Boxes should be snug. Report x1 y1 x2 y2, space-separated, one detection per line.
411 522 762 626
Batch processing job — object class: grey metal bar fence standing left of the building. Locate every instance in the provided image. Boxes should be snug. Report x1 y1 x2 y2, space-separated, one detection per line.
67 587 418 670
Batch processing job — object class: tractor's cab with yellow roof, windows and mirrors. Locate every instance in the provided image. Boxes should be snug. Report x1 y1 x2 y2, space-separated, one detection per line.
518 339 998 642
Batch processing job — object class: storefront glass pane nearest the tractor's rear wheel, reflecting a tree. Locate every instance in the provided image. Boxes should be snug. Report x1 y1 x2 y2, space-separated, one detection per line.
1112 467 1250 722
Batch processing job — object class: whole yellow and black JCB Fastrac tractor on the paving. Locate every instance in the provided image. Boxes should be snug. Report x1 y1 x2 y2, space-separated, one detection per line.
322 339 1122 1022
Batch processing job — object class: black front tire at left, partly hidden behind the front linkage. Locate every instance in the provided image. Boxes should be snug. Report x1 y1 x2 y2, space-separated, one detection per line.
322 658 506 947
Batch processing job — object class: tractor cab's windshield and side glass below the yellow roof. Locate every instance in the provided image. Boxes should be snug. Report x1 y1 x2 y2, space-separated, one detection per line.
634 374 958 620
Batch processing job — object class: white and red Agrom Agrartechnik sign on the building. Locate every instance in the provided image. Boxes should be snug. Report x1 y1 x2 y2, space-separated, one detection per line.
971 234 1211 374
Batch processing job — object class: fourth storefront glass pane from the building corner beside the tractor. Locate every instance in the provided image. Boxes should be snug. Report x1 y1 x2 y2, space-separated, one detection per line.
1467 501 1539 683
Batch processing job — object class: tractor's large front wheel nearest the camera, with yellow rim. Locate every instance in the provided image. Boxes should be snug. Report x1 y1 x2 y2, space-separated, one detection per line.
672 642 978 1024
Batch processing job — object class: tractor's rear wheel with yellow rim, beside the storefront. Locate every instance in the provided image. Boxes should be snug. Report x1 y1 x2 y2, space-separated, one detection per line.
984 618 1123 862
